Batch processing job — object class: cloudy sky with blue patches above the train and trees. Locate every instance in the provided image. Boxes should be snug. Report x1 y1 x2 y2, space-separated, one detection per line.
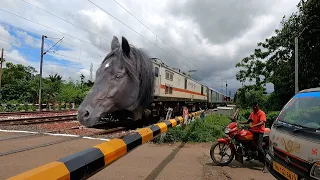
0 0 299 95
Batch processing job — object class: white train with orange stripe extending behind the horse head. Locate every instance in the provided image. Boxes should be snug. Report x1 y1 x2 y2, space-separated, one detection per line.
151 58 226 117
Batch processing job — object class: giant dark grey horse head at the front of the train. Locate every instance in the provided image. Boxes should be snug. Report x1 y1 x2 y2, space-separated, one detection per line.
78 36 154 127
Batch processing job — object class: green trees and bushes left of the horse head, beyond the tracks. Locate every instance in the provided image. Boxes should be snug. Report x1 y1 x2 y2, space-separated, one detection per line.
0 62 93 111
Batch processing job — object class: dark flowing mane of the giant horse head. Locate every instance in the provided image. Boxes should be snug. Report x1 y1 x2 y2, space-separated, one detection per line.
102 45 154 108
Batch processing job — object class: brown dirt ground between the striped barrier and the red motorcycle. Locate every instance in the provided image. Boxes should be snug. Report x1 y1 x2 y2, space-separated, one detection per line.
90 143 275 180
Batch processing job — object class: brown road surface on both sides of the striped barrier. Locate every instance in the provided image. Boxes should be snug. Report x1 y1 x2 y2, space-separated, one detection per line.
0 132 275 180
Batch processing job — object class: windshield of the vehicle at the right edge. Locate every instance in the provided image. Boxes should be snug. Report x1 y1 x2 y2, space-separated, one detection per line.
278 92 320 129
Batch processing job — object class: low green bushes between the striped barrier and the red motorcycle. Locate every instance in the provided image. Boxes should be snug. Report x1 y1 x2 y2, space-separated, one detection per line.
153 114 231 143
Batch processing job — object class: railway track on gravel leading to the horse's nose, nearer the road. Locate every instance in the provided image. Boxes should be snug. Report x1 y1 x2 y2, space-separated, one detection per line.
0 114 77 125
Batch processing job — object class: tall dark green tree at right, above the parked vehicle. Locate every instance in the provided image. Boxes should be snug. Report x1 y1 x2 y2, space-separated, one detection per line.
236 0 320 108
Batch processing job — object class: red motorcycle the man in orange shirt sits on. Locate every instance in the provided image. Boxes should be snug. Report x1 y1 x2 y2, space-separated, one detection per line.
210 120 270 166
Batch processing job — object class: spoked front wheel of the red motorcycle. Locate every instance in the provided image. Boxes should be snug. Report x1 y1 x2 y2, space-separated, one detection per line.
210 142 235 166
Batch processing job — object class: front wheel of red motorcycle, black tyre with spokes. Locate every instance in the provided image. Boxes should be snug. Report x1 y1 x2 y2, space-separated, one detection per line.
210 142 235 166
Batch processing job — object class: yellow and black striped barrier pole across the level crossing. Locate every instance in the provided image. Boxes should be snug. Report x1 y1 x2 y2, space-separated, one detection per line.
9 111 203 180
